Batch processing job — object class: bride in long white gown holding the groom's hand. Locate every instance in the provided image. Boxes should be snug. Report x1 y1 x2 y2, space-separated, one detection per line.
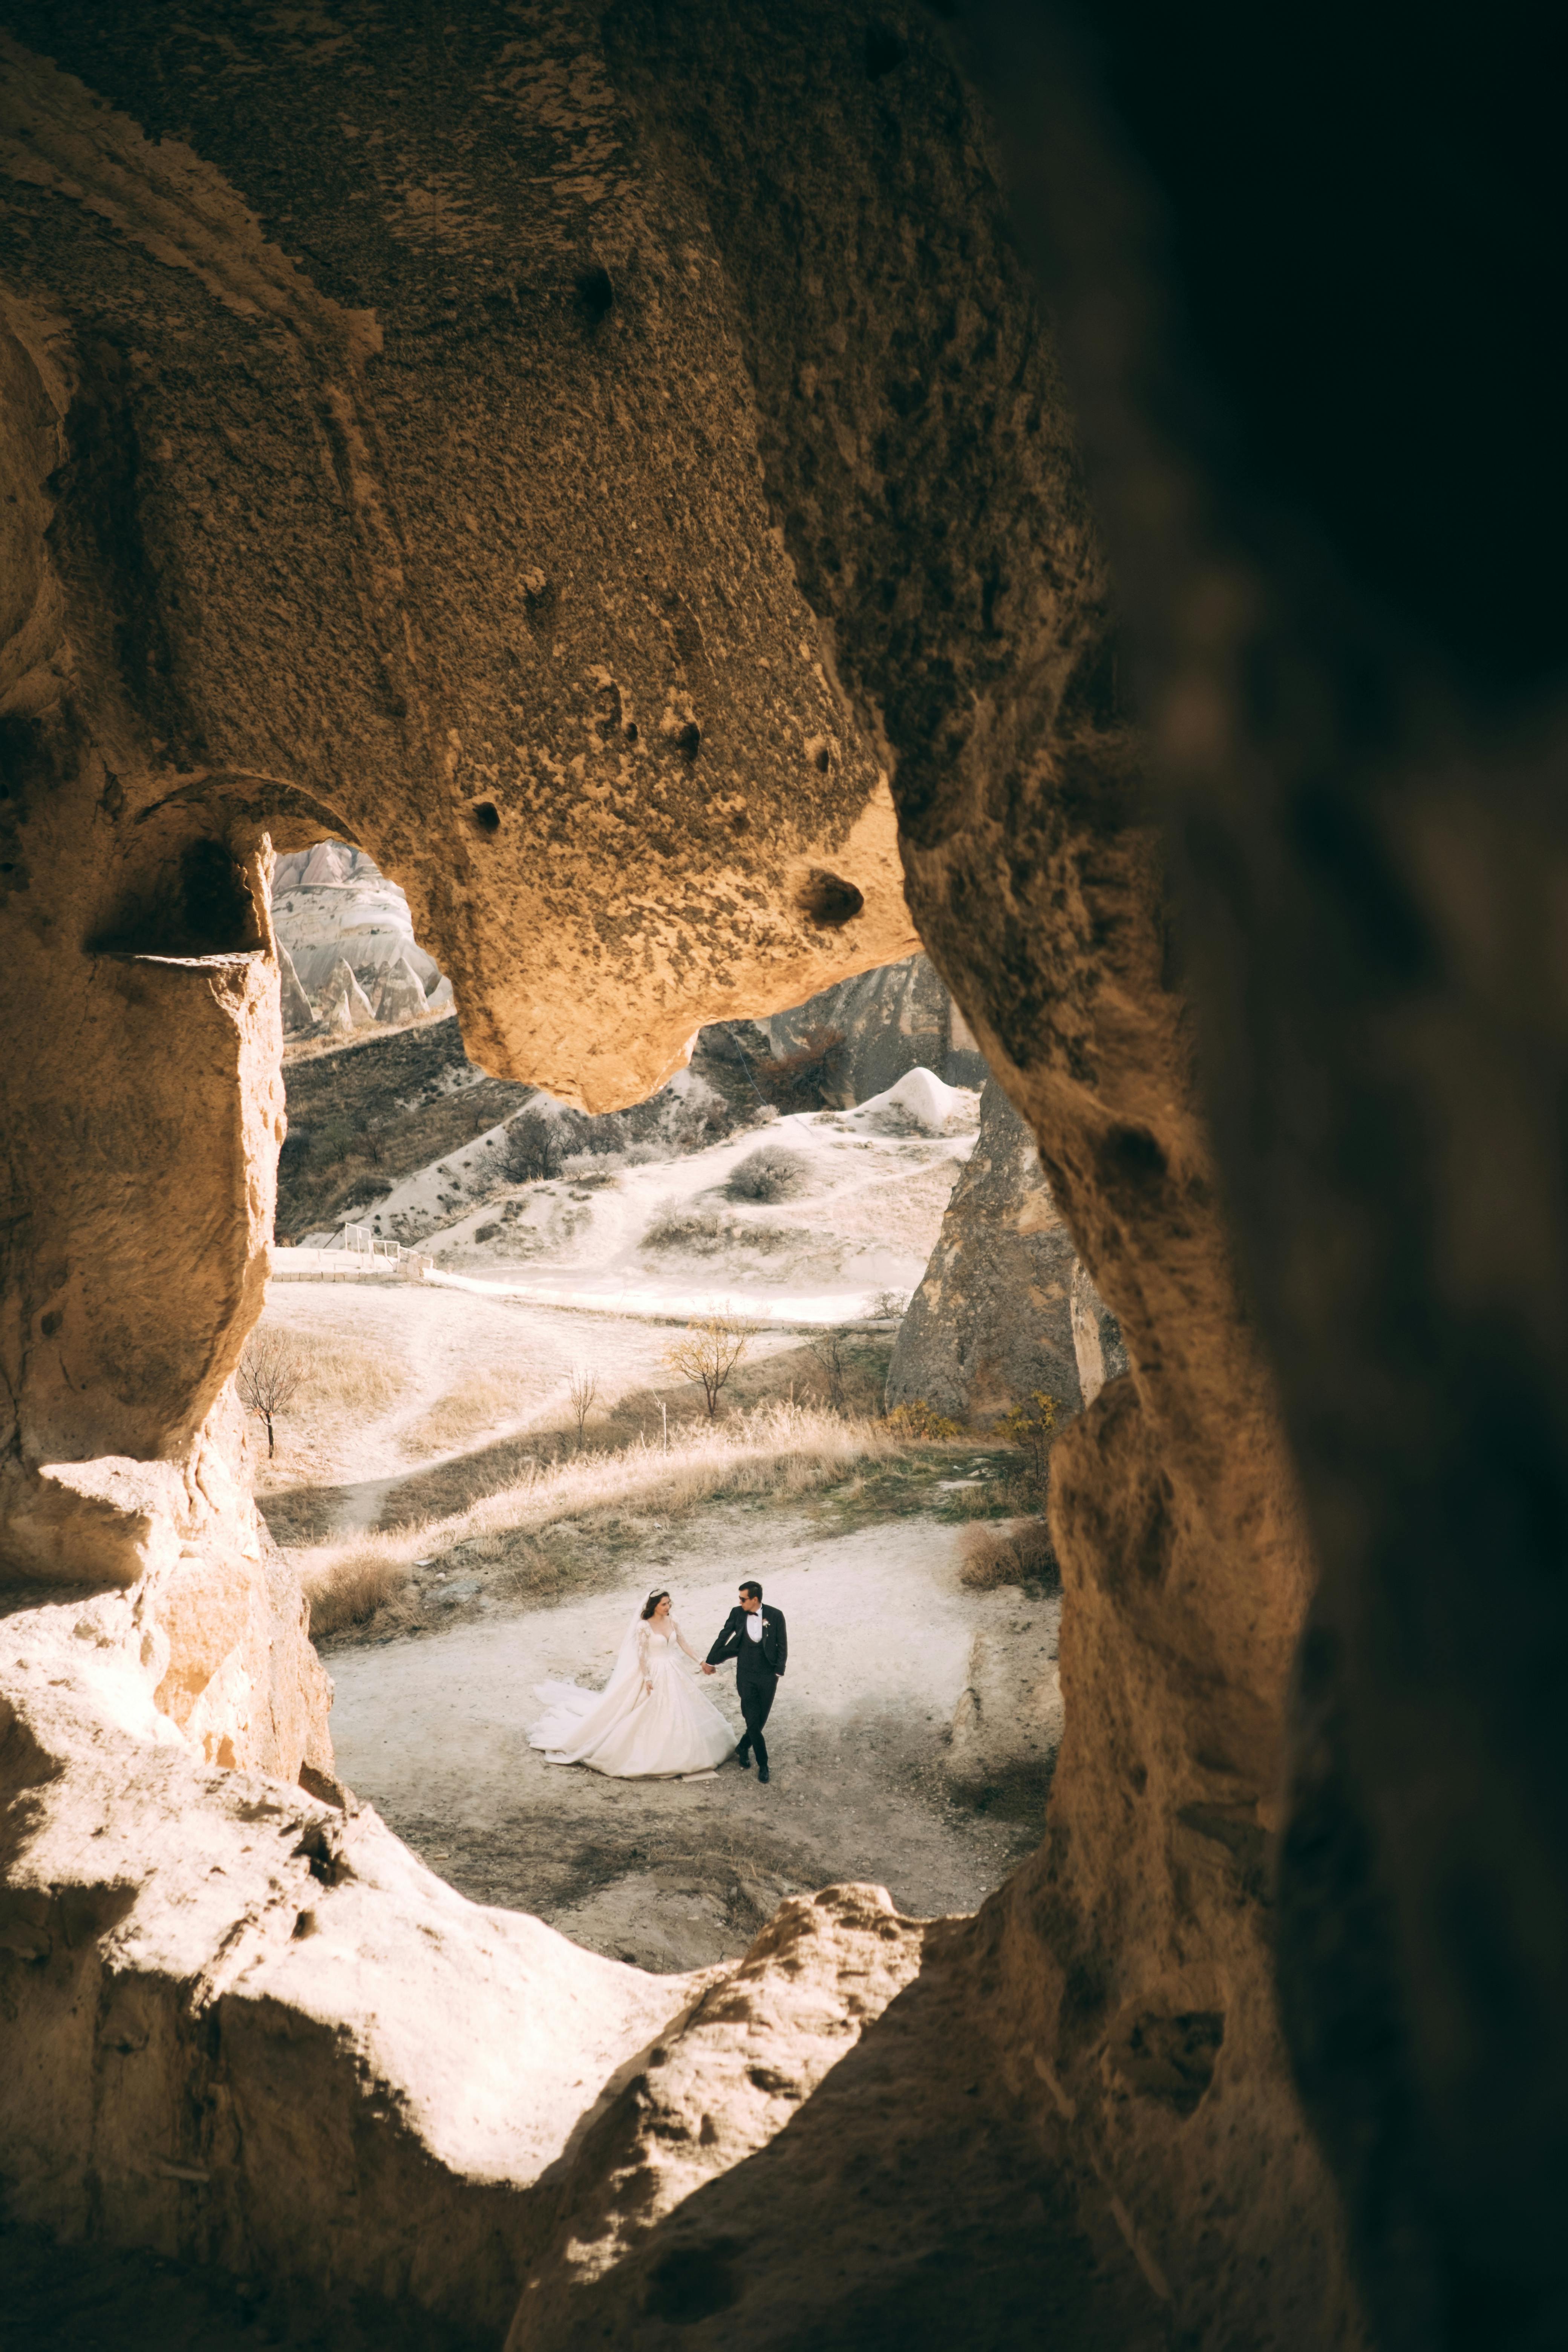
529 1592 736 1781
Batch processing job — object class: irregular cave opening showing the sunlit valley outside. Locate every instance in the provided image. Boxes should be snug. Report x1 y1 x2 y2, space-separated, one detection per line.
255 840 1081 1973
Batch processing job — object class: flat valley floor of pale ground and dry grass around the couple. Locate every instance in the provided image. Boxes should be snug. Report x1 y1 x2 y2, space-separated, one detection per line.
251 1280 1060 1971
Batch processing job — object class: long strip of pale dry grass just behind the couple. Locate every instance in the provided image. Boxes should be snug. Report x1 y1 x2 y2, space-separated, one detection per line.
296 1404 907 1635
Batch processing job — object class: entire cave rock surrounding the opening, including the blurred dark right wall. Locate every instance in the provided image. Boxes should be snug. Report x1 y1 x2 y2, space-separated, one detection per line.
0 0 1568 2352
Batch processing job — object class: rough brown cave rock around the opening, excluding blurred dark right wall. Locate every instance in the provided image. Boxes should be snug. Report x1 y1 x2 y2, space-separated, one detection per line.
0 0 1420 2352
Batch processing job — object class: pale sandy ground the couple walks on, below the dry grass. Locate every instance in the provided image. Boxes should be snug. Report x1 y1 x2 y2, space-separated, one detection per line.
329 1503 1039 1971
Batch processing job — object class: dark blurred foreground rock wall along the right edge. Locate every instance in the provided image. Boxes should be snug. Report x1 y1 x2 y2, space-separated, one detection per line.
971 7 1568 2352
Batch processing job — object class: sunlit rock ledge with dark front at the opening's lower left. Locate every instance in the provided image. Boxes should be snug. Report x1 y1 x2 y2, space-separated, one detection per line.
0 1592 696 2340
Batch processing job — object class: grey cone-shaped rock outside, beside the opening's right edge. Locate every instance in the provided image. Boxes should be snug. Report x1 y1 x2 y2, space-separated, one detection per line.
886 1080 1100 1428
